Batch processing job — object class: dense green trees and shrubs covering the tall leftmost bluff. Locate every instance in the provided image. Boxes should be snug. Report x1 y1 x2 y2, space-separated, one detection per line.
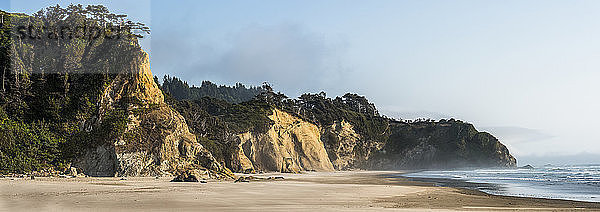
0 5 149 173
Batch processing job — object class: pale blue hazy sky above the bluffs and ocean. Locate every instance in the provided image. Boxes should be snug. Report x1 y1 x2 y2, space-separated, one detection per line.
0 0 600 162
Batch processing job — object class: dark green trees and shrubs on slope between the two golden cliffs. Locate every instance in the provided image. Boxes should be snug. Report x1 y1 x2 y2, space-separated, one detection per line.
155 76 273 162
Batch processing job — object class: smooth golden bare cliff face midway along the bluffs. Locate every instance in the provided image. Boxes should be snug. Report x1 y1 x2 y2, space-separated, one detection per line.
230 109 334 172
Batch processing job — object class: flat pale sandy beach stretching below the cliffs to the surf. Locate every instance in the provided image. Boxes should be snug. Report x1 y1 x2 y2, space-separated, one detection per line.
0 171 600 211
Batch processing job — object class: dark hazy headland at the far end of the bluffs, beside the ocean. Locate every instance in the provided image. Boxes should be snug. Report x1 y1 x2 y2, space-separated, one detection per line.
364 121 516 169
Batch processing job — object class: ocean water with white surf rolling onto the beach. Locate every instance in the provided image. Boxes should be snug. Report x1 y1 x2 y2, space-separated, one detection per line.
402 165 600 202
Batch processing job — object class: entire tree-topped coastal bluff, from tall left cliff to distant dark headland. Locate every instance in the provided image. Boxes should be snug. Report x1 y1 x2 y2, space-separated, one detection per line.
0 8 516 179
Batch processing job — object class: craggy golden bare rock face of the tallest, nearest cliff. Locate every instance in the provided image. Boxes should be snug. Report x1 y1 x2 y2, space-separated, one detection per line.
77 50 231 178
